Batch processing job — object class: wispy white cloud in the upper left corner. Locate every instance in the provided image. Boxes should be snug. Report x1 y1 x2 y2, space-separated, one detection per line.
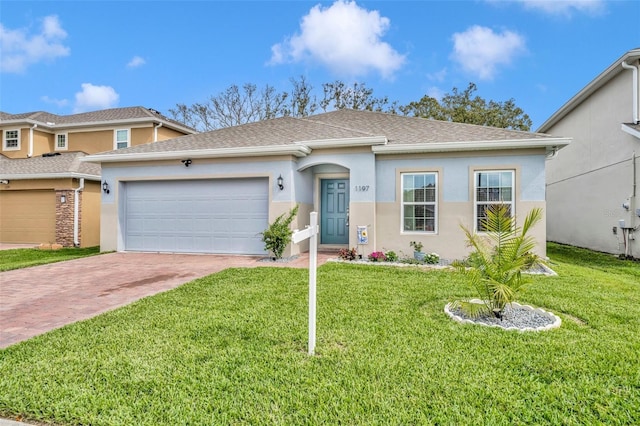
0 15 71 73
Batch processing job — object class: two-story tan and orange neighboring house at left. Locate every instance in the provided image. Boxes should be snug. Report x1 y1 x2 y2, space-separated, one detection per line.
0 107 195 247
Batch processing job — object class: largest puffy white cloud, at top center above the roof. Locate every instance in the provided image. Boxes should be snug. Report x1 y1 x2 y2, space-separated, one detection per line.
270 0 405 78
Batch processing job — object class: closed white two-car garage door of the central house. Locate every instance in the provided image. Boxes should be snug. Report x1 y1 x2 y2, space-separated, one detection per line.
124 179 269 254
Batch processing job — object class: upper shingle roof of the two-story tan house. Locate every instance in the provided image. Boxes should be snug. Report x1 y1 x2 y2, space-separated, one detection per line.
0 106 195 132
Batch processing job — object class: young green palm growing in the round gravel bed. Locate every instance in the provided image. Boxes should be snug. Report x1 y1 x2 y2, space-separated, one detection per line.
453 204 543 318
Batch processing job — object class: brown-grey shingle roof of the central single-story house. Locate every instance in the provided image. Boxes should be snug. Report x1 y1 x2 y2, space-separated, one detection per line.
92 110 551 157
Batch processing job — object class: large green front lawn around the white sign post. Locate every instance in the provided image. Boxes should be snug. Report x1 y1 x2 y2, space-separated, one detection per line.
0 241 640 425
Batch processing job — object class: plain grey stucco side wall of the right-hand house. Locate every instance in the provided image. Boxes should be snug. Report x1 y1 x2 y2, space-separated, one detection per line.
547 68 640 256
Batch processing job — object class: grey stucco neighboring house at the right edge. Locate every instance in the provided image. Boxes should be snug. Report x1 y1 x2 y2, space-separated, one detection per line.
538 49 640 257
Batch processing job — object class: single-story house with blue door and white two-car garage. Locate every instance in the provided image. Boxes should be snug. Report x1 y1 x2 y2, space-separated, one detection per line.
83 110 570 258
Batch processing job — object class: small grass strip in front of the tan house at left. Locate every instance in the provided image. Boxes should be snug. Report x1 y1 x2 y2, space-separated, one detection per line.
0 246 100 271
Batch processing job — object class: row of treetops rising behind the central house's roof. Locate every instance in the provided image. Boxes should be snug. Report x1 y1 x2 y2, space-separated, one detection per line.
169 76 531 131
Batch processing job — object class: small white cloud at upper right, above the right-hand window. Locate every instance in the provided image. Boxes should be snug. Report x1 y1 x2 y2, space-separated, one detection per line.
451 25 526 80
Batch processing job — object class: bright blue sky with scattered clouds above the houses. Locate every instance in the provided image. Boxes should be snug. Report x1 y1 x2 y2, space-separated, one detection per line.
0 0 640 129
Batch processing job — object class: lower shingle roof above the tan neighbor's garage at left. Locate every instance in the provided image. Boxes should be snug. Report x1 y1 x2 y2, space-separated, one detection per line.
0 152 100 179
